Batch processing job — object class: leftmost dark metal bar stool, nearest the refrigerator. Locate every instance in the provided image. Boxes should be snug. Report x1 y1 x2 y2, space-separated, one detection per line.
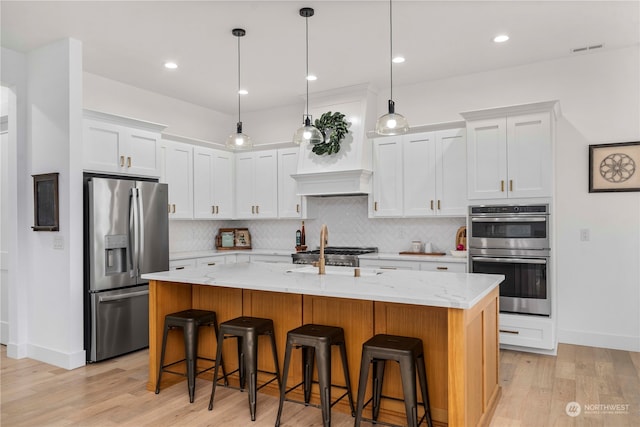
156 309 225 403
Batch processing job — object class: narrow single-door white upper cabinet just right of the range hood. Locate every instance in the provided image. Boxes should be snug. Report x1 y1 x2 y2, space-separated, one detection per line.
370 136 403 217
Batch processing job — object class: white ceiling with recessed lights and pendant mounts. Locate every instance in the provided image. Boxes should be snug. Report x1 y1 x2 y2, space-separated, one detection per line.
0 0 640 114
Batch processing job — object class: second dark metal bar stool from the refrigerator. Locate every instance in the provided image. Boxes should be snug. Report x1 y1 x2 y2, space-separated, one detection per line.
209 316 280 421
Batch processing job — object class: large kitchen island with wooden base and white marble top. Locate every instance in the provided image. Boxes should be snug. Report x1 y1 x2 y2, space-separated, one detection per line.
143 263 504 426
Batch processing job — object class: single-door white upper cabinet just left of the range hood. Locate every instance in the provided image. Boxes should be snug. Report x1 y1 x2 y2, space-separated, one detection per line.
278 147 307 218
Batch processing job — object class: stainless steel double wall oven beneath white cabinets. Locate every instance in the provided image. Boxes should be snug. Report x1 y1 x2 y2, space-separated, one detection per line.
468 204 551 316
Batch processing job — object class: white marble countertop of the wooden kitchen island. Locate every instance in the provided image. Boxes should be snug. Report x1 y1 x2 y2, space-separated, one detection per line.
142 262 504 309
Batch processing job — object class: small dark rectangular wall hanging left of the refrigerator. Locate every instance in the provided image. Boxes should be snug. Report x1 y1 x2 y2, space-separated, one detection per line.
31 173 60 231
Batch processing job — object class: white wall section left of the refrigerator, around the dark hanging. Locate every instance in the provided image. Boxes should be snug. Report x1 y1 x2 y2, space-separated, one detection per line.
2 39 85 369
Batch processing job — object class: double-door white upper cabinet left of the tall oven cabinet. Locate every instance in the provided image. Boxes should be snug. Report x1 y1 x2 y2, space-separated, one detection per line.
402 128 467 217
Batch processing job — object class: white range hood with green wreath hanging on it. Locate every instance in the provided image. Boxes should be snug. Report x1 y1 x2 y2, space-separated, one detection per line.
291 85 376 196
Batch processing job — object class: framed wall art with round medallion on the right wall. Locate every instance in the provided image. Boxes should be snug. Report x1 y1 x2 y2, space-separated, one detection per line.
589 141 640 193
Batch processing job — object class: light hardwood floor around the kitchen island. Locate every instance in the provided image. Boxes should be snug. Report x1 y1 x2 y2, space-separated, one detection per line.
0 344 640 427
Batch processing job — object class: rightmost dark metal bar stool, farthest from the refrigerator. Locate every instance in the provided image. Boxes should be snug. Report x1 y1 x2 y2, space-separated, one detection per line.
354 334 431 427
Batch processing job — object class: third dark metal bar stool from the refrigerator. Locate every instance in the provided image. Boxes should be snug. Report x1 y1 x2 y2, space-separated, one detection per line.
276 324 355 427
